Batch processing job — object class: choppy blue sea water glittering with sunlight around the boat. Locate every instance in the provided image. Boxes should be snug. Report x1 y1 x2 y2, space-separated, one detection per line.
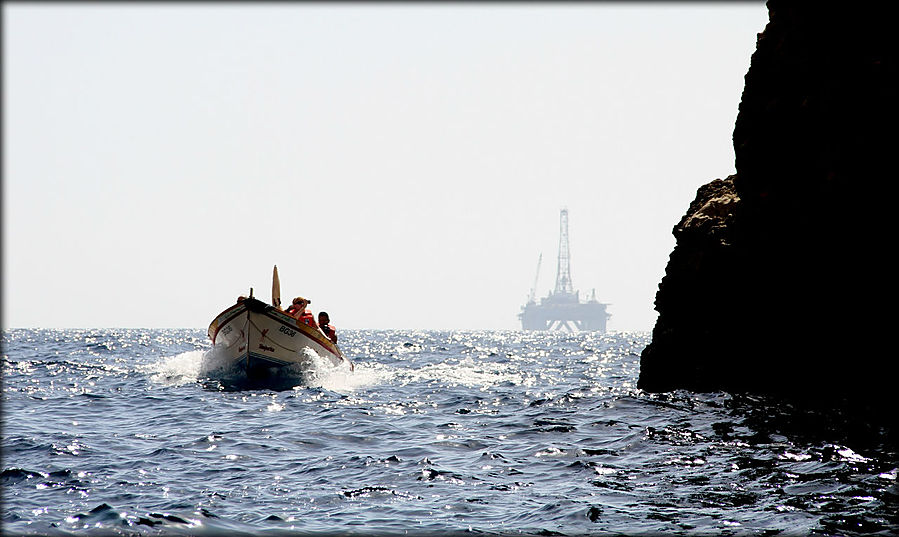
0 329 899 535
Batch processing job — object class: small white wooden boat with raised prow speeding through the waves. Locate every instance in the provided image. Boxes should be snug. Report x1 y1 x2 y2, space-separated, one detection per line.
206 266 353 378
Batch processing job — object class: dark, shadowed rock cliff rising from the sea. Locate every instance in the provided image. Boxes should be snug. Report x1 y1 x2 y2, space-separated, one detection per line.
638 0 899 402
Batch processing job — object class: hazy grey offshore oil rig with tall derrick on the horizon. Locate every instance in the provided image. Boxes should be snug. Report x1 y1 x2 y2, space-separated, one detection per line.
518 209 611 332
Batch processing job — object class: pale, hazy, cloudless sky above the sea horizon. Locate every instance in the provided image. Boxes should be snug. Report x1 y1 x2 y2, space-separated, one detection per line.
2 1 767 330
